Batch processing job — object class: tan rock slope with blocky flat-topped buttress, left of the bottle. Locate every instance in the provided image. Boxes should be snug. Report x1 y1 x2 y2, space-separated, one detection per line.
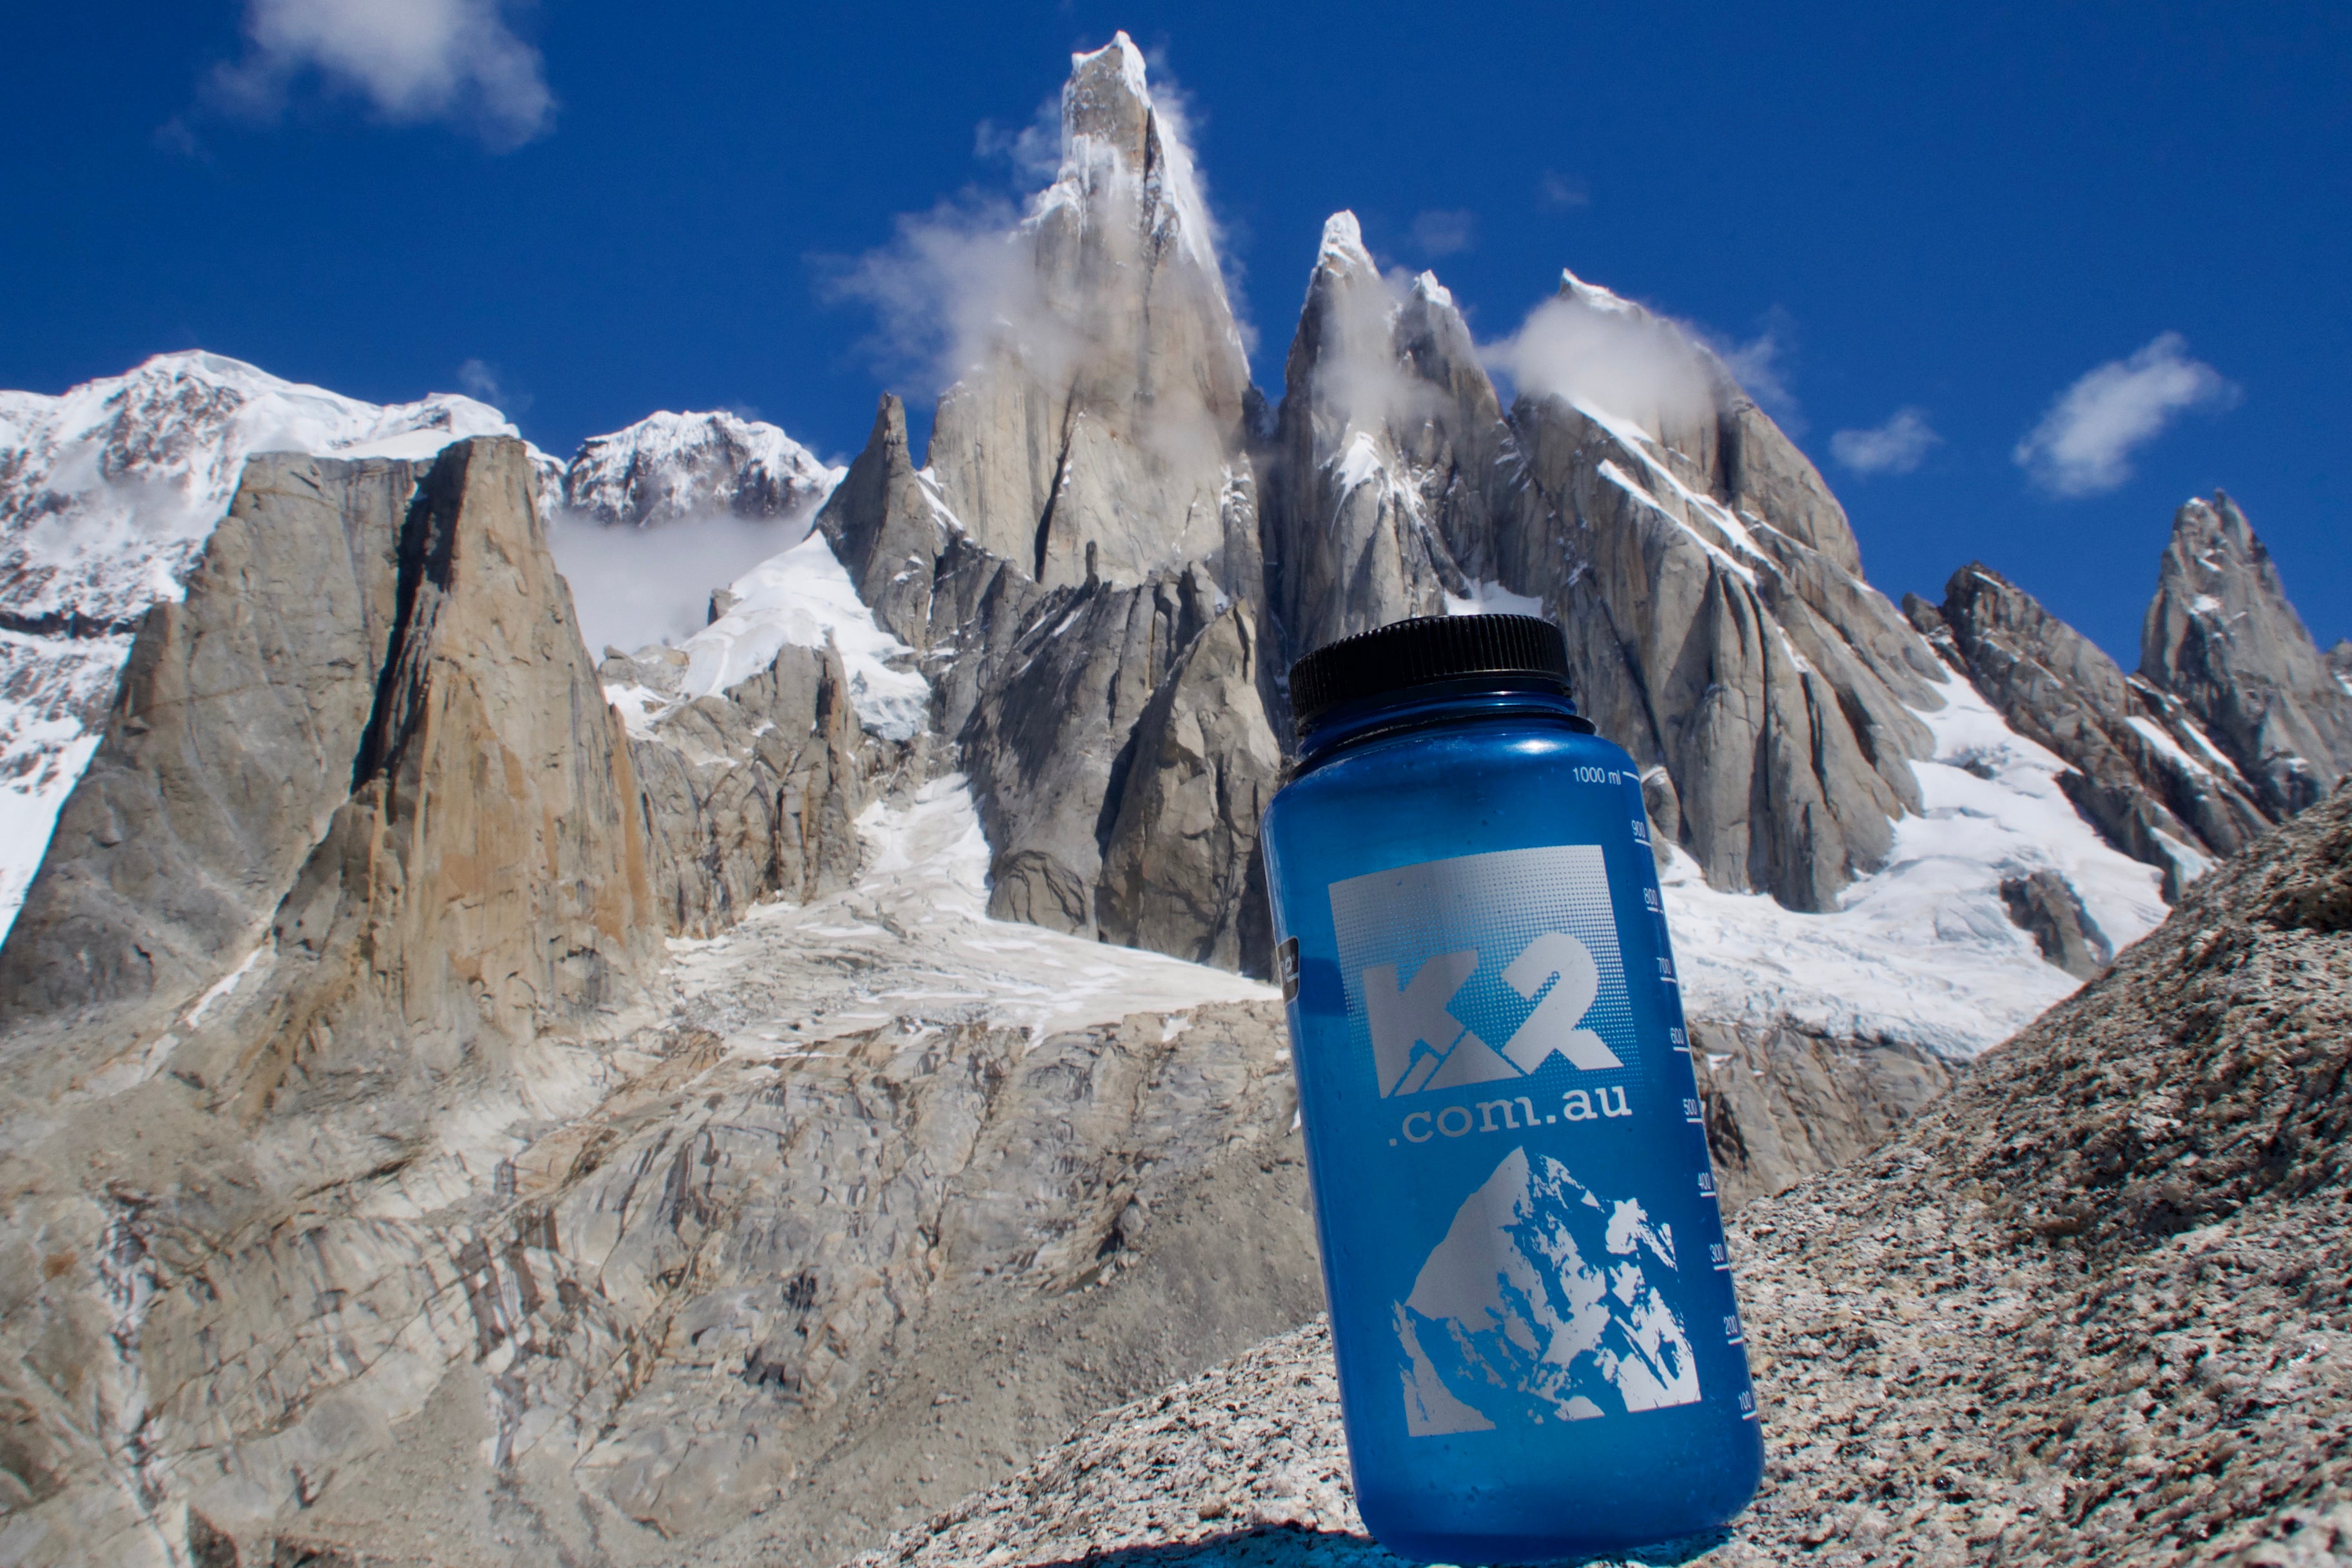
0 440 1315 1563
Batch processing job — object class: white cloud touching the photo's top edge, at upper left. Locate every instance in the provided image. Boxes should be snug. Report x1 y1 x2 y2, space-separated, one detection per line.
210 0 555 150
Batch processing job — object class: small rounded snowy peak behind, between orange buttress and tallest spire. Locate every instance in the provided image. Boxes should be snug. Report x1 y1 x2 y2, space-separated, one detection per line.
562 411 847 529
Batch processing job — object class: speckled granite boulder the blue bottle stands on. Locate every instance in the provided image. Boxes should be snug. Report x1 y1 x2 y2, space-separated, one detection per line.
859 790 2352 1568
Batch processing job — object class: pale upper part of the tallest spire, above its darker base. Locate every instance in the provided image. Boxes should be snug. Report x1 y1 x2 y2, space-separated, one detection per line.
932 33 1256 590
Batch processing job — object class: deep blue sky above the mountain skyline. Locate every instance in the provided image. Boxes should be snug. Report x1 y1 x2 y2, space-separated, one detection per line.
0 0 2352 665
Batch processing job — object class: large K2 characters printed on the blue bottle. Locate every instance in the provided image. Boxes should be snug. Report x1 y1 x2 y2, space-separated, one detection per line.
1364 931 1625 1098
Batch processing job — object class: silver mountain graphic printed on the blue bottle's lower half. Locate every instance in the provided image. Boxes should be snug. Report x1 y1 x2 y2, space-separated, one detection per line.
1395 1147 1698 1436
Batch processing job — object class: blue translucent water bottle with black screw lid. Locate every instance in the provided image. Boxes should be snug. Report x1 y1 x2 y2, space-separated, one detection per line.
1263 616 1764 1563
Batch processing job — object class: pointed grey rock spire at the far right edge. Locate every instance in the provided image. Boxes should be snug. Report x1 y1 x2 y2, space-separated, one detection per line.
2141 491 2352 816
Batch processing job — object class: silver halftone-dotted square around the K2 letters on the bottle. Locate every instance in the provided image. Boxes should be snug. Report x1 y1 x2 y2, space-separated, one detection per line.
1331 844 1647 1086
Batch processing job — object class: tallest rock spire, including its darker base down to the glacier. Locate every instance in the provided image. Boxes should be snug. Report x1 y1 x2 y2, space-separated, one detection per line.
816 33 1282 974
